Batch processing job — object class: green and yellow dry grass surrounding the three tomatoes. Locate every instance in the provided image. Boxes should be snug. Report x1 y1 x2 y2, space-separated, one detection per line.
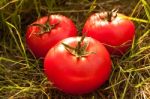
0 0 150 99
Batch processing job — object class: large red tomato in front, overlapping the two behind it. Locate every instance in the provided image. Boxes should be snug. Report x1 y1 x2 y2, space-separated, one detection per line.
44 37 111 94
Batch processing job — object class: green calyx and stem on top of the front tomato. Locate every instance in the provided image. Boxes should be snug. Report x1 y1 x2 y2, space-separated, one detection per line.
62 36 94 58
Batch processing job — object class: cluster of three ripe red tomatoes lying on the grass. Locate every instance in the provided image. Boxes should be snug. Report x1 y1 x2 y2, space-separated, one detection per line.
26 12 135 94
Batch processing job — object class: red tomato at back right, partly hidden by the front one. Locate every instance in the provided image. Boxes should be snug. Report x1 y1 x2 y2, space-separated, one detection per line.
82 12 135 55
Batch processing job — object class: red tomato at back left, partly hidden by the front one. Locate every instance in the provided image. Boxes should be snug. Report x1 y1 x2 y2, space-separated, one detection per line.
26 14 77 58
